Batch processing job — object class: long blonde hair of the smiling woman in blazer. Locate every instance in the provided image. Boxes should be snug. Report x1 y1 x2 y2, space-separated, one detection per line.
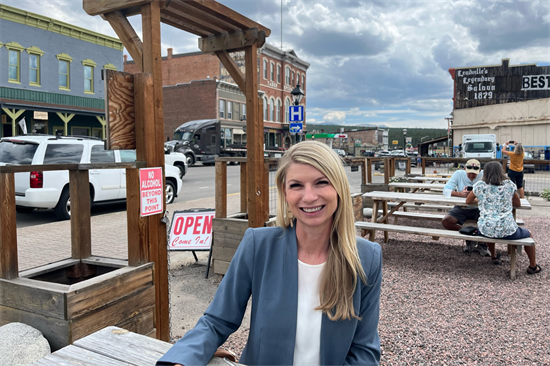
275 141 367 320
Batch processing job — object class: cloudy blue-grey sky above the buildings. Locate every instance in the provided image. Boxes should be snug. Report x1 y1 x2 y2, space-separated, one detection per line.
5 0 550 128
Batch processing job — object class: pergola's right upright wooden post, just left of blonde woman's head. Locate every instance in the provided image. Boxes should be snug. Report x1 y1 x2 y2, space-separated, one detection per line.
245 44 268 227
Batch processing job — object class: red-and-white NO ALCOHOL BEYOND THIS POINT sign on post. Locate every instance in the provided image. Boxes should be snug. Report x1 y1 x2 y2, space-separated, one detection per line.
139 168 164 217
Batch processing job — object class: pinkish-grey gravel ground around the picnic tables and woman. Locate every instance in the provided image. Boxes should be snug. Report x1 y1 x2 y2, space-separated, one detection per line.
172 210 550 366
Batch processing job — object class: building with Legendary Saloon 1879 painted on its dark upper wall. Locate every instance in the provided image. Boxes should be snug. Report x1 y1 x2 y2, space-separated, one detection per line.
449 59 550 158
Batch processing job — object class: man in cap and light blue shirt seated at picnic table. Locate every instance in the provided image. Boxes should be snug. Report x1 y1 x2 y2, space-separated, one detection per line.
441 159 491 256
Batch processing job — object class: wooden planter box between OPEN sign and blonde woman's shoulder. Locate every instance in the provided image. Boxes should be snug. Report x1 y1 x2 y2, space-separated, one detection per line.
212 213 275 275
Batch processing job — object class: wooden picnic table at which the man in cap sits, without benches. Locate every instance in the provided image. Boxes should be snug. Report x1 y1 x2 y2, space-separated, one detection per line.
363 191 531 242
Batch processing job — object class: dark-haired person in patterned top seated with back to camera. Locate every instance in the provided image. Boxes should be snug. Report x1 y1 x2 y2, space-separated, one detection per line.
466 161 542 274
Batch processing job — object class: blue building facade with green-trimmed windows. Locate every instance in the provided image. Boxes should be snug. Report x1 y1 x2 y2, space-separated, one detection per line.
0 4 123 138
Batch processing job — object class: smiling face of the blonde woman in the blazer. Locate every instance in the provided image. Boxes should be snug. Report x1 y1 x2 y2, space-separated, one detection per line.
284 163 338 229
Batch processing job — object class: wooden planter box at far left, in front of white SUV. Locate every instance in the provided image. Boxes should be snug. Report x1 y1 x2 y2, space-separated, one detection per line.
0 257 155 351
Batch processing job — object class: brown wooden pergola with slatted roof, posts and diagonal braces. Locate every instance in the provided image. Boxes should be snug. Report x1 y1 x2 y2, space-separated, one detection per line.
83 0 271 340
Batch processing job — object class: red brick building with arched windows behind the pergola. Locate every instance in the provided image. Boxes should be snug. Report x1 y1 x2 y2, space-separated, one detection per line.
124 44 309 148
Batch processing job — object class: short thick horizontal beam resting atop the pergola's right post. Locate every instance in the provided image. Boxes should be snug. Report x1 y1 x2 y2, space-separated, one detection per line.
199 28 265 53
